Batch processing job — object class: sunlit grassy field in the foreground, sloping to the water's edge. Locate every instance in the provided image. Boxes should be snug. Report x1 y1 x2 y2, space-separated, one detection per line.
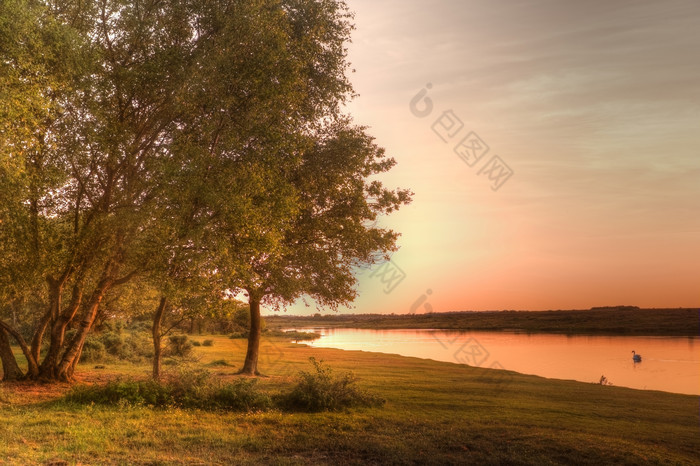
0 336 700 465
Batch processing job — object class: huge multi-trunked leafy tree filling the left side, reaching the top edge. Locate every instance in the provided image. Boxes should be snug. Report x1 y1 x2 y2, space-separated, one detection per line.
0 0 366 380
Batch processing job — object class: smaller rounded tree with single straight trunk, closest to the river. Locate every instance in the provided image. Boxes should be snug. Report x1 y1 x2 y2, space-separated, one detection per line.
228 118 411 375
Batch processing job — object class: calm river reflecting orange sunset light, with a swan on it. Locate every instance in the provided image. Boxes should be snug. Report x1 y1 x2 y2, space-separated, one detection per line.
298 328 700 395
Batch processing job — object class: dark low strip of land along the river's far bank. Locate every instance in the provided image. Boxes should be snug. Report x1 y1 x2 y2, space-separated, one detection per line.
265 306 700 337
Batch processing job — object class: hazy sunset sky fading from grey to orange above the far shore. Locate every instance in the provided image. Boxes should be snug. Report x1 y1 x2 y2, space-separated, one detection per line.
282 0 700 314
